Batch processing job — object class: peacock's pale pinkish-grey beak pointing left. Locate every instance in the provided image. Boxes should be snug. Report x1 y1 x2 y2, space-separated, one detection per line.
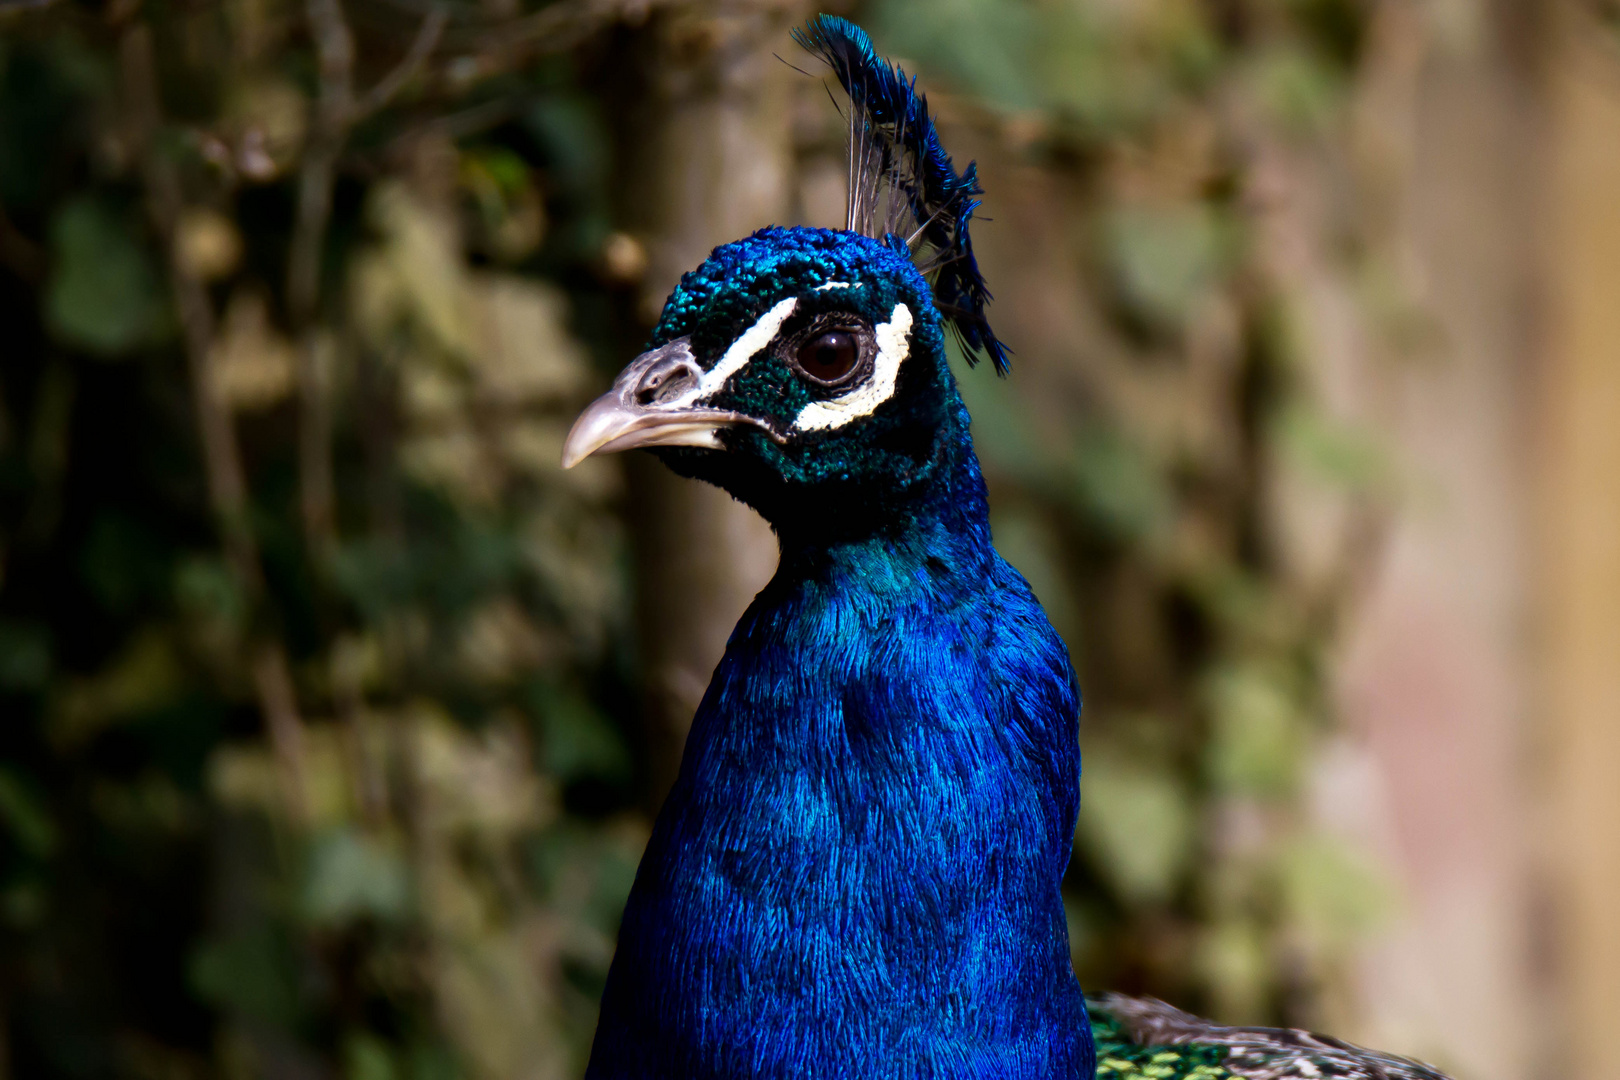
562 337 774 468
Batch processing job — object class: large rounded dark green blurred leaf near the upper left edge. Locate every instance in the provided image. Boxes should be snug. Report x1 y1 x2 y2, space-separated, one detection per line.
45 196 165 356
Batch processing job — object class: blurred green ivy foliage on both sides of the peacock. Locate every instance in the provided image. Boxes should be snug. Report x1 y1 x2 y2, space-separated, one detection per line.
0 0 1390 1080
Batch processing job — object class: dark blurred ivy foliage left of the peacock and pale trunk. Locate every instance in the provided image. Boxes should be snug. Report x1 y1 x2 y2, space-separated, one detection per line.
0 3 646 1080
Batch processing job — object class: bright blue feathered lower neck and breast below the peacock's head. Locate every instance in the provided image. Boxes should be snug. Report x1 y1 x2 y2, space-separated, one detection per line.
583 553 1084 1075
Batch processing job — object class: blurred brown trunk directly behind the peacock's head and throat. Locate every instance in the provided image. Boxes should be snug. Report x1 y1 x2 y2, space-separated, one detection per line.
622 0 802 806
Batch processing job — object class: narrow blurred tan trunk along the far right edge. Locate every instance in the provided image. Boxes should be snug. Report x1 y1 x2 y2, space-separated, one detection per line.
1536 3 1620 1080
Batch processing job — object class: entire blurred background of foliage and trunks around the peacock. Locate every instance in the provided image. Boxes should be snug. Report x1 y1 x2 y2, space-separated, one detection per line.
0 0 1620 1080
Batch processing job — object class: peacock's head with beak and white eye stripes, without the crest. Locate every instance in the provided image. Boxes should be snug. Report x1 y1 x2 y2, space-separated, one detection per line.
564 228 966 523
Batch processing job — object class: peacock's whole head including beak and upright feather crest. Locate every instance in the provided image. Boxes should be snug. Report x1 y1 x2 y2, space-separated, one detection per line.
564 16 1006 529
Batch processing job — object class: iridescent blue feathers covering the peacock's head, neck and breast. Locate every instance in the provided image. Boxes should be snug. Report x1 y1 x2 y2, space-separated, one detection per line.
590 230 1092 1080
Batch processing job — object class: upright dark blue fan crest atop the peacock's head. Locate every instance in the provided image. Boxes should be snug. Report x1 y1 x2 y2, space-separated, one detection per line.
794 15 1008 374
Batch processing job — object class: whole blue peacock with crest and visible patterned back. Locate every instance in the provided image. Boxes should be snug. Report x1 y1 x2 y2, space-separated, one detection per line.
564 15 1440 1080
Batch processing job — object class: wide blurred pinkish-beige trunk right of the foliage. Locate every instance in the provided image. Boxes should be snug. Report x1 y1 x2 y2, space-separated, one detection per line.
1325 3 1542 1080
